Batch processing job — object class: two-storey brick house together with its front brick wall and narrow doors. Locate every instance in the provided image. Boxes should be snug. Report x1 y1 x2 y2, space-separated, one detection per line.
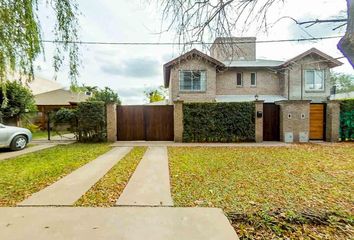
163 37 342 142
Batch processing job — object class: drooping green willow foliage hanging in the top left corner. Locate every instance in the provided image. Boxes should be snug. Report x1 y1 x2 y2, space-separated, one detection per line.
0 0 79 84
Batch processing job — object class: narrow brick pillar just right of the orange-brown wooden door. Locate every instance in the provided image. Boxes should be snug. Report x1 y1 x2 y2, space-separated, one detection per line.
326 101 340 142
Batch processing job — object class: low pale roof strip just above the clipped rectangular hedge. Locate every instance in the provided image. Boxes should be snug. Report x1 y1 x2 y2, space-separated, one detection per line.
215 95 287 103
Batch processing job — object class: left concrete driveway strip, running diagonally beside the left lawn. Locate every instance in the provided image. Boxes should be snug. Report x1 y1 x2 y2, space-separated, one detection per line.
19 147 132 206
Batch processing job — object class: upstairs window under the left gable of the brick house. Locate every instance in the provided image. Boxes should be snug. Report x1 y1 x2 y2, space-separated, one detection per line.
179 71 206 92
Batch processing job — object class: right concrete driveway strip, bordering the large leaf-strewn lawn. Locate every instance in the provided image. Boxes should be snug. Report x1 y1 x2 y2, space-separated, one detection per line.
116 147 173 206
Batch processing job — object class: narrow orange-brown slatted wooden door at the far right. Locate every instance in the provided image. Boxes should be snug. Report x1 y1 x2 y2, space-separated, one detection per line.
310 103 326 140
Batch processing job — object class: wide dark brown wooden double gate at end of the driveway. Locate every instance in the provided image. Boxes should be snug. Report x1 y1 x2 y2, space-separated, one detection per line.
117 105 174 141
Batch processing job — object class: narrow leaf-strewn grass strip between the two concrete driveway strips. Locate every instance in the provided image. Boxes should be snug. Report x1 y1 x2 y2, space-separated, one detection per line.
75 147 146 207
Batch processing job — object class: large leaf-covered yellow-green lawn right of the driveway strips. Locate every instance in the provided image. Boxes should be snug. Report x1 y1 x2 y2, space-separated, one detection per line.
169 144 354 239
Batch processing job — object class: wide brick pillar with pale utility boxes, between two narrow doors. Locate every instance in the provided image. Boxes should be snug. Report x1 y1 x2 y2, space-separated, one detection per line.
277 100 311 142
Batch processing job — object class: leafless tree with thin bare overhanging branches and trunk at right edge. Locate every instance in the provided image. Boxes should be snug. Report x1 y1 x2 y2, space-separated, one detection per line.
157 0 354 66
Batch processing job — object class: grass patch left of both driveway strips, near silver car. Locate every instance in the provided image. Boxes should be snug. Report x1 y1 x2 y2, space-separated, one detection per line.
0 144 111 206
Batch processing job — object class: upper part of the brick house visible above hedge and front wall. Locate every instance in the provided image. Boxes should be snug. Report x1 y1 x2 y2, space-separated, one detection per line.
164 37 342 104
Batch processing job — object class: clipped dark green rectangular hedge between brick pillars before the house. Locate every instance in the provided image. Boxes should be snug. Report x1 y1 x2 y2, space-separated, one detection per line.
183 102 255 142
